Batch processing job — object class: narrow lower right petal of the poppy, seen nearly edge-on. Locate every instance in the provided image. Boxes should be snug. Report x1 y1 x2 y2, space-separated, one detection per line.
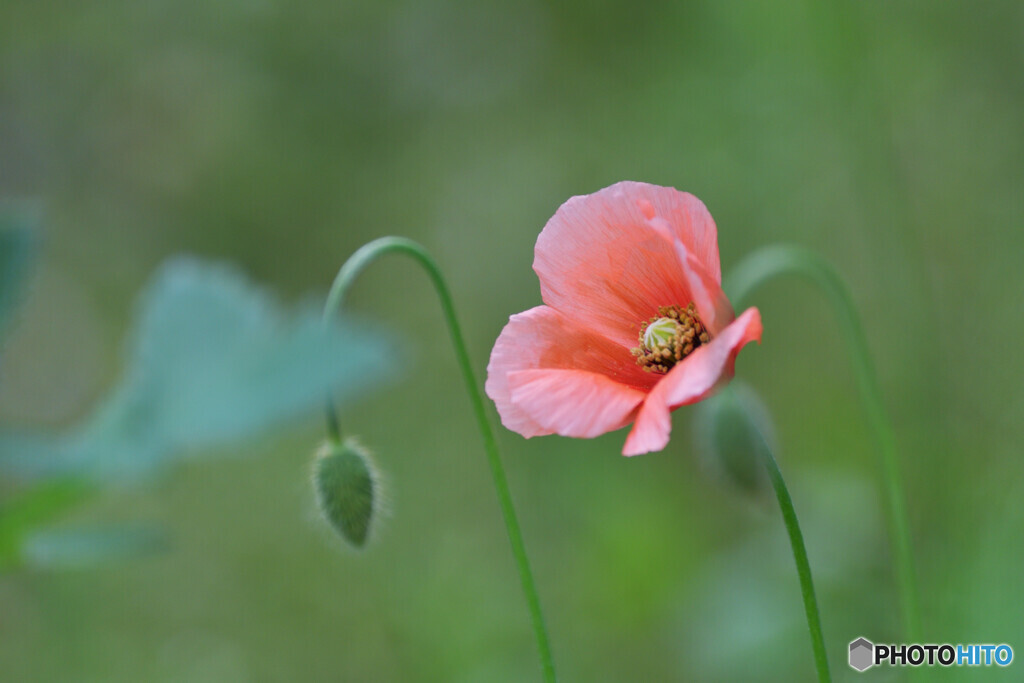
623 308 761 456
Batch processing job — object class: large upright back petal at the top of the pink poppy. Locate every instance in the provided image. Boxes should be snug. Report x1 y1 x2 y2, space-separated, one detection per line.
534 182 721 346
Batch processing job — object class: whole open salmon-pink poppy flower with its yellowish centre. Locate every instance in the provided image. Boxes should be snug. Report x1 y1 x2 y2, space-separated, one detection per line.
486 182 761 456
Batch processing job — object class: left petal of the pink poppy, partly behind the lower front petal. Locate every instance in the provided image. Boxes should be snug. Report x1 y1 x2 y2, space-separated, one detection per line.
484 306 658 438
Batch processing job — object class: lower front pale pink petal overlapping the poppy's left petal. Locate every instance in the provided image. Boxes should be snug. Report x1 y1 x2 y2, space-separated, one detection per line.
508 370 647 438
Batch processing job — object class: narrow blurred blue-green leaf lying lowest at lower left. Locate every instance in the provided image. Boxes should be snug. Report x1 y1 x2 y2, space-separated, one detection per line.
22 524 170 569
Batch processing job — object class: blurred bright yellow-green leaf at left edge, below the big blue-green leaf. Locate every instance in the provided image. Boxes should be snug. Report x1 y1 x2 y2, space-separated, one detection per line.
0 479 89 570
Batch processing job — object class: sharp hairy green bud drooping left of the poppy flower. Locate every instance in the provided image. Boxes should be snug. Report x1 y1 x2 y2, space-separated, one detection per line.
313 438 380 548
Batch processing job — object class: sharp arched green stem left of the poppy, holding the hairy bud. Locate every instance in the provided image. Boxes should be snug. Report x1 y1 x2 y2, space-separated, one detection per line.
324 238 555 682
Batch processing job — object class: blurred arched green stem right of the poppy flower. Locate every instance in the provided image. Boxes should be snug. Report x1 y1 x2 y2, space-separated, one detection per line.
729 246 921 643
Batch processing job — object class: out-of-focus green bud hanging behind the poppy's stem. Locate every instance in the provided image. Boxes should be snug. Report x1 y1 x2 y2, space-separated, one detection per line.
693 381 775 496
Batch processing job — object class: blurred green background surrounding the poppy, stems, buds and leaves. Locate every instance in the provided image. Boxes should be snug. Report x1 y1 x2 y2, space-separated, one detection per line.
0 0 1024 682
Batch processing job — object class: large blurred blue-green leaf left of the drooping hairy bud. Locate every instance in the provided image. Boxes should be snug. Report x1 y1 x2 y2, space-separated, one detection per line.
0 258 396 480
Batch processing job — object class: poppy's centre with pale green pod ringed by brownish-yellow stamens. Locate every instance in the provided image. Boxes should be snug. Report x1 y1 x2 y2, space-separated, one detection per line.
633 303 711 375
